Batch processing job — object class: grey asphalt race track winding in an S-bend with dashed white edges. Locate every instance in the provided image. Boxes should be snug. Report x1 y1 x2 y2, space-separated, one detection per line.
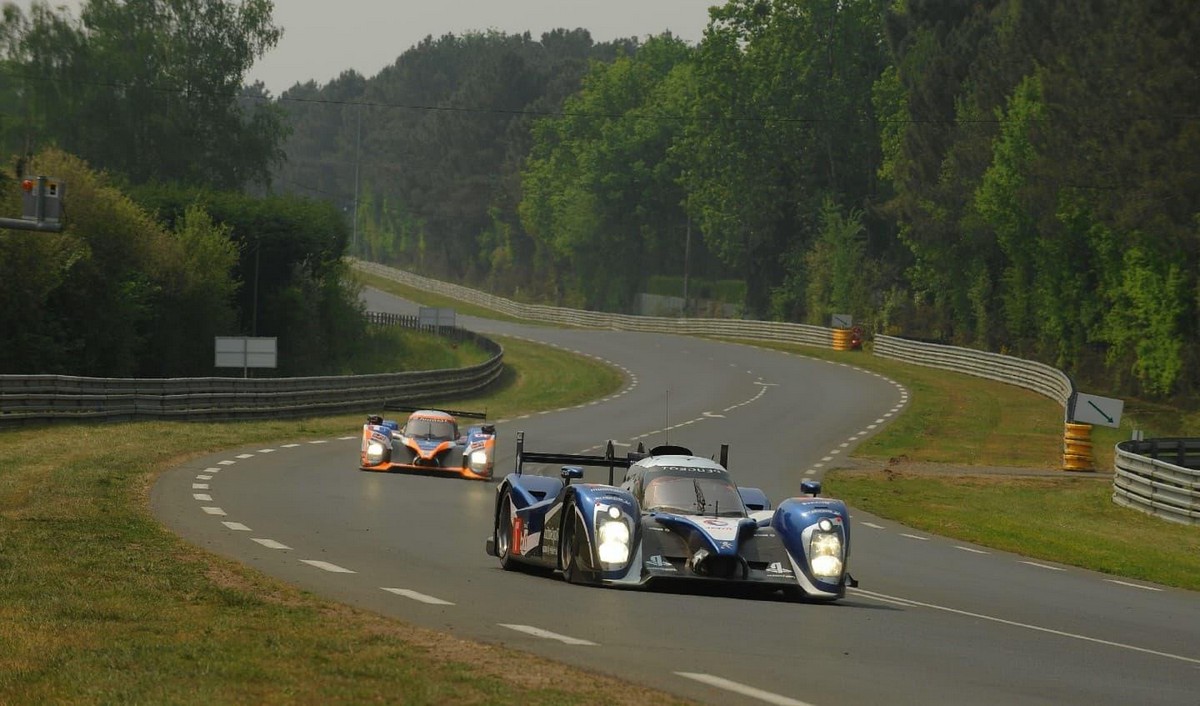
151 291 1200 706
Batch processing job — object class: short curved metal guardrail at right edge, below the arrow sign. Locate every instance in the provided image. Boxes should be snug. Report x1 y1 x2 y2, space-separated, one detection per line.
1112 438 1200 525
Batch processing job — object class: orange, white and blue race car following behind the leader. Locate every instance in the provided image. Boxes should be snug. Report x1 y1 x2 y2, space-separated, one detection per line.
359 405 496 480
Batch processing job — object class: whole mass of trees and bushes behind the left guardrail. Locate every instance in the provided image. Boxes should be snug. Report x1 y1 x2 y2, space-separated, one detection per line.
0 0 372 377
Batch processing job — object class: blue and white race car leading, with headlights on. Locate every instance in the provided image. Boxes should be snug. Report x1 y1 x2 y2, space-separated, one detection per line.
486 432 858 600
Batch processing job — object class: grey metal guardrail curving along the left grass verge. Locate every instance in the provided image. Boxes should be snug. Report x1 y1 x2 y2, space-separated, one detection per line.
0 315 504 426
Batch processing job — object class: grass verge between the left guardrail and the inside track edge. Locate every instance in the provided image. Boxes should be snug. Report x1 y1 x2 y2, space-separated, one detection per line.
0 339 678 705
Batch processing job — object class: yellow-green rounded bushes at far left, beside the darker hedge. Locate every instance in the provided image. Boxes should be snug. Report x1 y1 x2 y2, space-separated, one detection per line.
0 150 238 377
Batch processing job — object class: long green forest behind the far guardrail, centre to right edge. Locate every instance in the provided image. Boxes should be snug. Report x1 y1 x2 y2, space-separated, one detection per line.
278 0 1200 397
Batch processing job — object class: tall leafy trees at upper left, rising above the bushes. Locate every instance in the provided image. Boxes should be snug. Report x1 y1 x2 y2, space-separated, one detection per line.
0 0 284 189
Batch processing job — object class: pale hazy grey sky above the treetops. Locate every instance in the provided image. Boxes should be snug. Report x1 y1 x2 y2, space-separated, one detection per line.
17 0 724 96
